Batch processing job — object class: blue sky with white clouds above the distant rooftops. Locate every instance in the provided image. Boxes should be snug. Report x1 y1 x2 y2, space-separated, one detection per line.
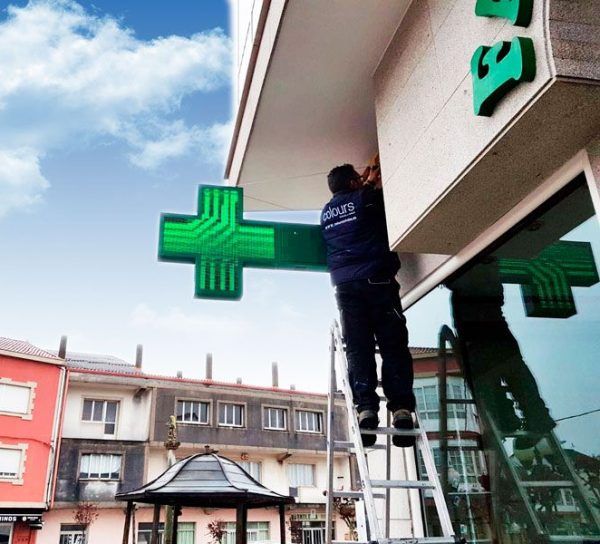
0 0 346 390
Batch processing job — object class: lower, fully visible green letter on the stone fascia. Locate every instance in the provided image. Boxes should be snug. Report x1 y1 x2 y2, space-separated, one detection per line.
471 37 535 117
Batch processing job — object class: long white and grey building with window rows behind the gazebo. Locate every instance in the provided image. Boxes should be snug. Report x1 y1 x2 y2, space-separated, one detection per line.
38 354 352 544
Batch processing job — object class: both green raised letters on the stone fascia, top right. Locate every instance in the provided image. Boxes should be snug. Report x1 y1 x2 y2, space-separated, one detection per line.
471 0 536 117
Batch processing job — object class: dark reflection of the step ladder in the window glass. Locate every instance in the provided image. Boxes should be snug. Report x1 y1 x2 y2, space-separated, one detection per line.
438 325 600 542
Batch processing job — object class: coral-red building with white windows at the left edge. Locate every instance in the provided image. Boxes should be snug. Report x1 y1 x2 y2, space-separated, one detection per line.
0 338 67 544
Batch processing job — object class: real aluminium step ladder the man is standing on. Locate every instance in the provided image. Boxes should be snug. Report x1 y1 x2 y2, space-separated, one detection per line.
325 322 456 544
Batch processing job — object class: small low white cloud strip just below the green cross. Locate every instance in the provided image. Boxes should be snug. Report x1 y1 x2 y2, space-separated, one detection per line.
131 304 250 336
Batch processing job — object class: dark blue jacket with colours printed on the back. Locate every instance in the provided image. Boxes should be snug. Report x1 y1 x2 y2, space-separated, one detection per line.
321 187 400 285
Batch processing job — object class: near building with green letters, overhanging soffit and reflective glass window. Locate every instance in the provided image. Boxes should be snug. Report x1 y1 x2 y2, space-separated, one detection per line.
226 0 600 543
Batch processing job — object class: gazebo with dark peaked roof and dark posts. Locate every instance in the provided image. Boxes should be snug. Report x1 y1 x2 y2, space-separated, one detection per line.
115 453 295 544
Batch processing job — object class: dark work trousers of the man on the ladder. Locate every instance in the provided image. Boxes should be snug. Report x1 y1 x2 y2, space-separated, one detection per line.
336 279 415 412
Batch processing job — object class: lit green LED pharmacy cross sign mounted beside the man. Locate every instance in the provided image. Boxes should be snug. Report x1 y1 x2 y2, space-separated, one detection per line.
158 185 327 300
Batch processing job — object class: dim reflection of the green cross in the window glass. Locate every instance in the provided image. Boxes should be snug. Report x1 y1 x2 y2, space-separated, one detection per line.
499 242 599 319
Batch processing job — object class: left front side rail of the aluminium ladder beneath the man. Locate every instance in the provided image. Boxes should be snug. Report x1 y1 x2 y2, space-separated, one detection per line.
333 323 383 541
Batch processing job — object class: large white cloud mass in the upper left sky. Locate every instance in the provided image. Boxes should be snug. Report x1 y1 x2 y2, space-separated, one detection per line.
0 0 230 216
